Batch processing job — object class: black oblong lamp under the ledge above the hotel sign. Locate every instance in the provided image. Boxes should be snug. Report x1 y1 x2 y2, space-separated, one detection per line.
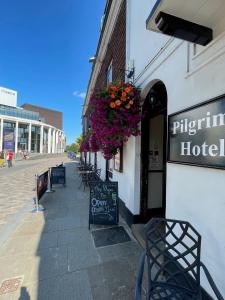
155 11 213 46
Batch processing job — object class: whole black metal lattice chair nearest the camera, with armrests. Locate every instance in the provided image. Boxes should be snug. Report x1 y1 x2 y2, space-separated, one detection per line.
135 218 224 300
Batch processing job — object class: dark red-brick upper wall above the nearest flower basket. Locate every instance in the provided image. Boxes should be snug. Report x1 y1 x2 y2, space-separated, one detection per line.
95 0 126 90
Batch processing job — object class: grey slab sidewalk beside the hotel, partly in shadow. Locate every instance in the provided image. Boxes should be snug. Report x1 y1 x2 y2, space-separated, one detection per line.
0 162 141 300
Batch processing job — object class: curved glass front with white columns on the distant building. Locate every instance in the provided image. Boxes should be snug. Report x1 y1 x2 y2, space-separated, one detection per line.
0 104 65 154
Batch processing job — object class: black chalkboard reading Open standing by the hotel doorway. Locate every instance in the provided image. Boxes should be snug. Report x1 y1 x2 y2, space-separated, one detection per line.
89 181 118 228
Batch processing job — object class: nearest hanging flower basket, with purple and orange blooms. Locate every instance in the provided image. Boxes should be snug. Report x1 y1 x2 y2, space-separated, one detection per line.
90 82 141 159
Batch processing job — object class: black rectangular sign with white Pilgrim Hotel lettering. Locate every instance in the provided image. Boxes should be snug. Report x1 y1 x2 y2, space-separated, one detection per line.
168 96 225 169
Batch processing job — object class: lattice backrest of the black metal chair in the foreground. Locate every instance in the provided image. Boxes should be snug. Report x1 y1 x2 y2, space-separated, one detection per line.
145 218 201 295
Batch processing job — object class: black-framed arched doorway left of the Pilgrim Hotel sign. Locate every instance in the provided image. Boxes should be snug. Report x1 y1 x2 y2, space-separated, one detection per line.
140 82 167 222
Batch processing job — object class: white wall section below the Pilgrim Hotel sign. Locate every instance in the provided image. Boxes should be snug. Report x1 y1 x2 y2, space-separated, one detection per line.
166 164 225 295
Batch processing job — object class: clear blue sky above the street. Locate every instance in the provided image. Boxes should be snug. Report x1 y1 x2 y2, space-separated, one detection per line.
0 0 105 143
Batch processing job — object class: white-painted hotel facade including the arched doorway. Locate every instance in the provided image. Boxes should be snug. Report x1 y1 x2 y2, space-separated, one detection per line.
83 0 225 296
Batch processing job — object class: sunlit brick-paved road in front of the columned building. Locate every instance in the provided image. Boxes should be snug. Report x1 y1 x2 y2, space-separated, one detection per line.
0 154 69 233
